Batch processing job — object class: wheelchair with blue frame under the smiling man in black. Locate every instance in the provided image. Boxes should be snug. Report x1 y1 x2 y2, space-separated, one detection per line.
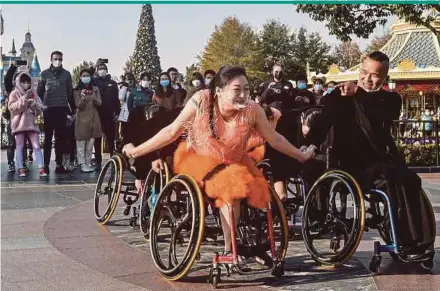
302 163 436 274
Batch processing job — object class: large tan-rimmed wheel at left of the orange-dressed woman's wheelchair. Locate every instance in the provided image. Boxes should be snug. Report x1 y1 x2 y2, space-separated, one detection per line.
150 175 205 281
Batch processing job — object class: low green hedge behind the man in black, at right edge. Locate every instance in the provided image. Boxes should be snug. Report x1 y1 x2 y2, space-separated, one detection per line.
398 144 438 167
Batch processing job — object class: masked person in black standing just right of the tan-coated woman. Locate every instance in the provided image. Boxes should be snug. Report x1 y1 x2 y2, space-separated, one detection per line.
93 59 121 170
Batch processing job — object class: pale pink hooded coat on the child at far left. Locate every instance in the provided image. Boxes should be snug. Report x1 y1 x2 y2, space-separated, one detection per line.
8 72 45 134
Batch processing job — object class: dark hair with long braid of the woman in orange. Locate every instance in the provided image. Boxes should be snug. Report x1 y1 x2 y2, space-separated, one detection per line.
209 66 248 139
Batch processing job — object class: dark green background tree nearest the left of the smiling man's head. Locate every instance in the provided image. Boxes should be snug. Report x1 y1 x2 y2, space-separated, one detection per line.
292 27 336 74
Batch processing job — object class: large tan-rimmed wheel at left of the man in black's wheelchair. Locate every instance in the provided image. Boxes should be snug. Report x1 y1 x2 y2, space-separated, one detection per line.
302 170 365 266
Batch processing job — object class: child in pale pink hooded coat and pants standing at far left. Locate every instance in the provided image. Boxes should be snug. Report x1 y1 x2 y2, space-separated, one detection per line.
8 72 47 177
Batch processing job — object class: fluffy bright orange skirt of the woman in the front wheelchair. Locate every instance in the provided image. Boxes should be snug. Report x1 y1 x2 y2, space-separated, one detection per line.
174 142 271 208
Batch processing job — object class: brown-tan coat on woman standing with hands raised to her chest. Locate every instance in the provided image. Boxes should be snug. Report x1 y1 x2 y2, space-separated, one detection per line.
73 86 102 140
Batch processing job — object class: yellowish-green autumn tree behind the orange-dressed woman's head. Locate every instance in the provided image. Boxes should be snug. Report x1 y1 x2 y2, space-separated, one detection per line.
198 17 265 81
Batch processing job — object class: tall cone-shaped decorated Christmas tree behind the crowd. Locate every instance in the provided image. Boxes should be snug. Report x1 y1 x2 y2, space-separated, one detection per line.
124 4 161 81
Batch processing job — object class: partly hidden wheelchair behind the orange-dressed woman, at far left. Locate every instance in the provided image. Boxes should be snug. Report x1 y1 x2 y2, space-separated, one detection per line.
94 105 170 228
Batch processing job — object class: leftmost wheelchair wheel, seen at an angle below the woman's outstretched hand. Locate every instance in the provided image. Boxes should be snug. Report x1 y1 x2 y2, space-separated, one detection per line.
94 155 124 225
